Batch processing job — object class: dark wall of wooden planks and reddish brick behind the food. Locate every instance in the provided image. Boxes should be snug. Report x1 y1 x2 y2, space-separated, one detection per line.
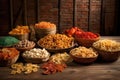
0 0 120 36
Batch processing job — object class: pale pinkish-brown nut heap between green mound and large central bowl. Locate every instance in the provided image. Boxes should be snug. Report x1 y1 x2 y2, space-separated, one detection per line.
14 39 35 48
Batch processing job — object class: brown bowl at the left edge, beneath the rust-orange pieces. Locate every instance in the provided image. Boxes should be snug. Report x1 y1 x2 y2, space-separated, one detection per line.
0 54 19 66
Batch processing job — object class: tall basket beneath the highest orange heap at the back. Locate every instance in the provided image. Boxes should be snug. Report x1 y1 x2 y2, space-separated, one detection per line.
35 27 56 40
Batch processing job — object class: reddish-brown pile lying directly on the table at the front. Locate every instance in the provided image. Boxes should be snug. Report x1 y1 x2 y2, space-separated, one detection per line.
41 62 67 75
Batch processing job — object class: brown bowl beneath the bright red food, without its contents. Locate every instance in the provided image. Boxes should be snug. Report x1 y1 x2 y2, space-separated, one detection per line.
75 34 100 47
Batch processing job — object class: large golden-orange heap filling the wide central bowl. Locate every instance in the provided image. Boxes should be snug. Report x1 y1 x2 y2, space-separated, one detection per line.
38 34 74 49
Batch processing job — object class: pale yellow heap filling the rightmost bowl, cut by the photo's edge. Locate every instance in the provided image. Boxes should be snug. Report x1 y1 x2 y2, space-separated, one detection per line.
93 39 120 51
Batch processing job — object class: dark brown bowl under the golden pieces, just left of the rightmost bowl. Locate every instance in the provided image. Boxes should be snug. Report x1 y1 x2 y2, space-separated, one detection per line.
70 54 98 64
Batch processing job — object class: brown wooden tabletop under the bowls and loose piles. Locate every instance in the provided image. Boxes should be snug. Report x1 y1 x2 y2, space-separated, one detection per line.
0 37 120 80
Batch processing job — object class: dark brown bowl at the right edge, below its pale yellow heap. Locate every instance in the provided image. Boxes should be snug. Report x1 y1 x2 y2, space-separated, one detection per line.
93 47 120 62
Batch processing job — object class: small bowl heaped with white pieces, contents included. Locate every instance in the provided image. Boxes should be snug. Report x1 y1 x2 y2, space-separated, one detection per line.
21 48 50 64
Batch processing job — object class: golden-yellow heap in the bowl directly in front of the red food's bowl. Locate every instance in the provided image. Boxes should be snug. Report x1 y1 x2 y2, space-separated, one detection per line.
70 46 97 58
